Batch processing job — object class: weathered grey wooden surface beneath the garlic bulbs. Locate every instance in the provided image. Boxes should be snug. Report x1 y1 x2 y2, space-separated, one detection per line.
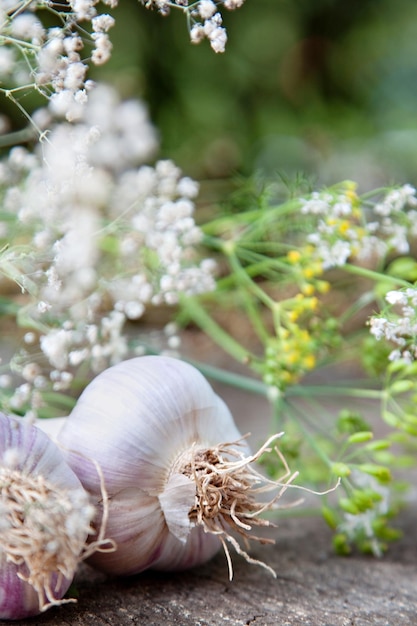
18 508 417 626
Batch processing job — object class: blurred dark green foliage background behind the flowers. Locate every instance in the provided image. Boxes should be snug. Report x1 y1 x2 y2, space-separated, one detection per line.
90 0 417 190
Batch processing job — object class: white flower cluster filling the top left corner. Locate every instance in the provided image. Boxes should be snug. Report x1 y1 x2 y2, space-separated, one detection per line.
0 0 117 120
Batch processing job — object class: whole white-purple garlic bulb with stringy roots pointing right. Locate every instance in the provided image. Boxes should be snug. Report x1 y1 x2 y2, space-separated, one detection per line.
58 356 286 575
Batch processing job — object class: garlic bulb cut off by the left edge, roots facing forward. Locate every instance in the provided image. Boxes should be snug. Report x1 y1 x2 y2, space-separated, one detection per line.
0 414 94 620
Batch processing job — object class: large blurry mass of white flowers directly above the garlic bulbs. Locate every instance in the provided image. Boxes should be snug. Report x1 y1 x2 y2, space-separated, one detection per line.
0 86 215 413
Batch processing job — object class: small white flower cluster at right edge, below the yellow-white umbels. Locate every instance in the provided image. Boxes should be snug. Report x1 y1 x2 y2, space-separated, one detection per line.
369 287 417 364
